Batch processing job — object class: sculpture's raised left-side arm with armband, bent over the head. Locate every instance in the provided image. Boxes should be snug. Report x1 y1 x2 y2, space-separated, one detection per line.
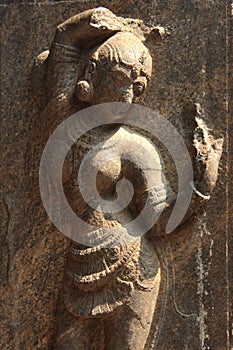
47 7 122 100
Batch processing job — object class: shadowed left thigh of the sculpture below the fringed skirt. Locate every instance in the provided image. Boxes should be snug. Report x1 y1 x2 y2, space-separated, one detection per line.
53 312 104 350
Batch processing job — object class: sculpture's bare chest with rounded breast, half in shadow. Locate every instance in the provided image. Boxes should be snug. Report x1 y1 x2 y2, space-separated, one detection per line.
63 131 121 194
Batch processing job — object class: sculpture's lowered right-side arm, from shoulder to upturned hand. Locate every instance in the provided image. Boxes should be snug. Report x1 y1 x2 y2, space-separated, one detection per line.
119 117 223 237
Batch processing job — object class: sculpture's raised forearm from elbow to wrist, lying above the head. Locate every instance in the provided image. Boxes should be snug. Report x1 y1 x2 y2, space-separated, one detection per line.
54 7 122 48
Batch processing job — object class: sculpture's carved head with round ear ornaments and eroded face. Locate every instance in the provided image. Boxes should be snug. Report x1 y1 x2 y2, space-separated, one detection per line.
76 32 152 104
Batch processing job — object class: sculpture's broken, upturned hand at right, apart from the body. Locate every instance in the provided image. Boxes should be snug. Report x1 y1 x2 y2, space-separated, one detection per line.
194 117 223 196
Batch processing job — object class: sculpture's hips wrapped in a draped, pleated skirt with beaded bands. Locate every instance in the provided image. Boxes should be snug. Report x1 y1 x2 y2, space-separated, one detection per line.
64 238 159 315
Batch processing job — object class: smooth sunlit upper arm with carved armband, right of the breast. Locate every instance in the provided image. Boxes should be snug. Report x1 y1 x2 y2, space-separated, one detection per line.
121 133 172 231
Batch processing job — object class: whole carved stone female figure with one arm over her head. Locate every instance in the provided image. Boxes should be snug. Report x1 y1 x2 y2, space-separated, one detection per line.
34 8 222 350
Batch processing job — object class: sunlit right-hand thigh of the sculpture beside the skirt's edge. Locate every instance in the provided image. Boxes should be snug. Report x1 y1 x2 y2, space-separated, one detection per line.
105 286 158 350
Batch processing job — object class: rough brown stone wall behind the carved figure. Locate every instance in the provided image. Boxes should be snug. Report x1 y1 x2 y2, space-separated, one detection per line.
0 0 233 350
